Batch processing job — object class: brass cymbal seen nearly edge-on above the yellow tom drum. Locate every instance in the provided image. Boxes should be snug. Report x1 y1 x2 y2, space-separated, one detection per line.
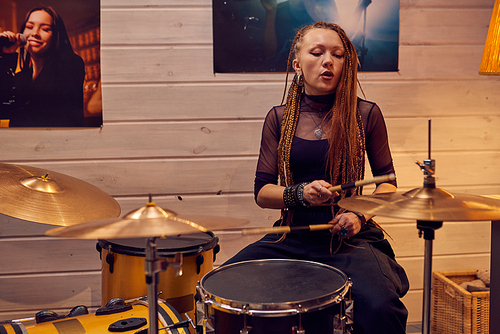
45 203 247 239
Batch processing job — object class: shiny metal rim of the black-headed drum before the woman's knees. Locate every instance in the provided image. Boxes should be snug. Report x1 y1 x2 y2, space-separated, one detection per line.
198 259 352 317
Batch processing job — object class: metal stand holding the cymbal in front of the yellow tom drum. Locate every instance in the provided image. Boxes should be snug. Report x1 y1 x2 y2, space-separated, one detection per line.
144 237 182 334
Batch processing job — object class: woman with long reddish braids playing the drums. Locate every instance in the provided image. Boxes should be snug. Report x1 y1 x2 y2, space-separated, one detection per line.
225 22 409 334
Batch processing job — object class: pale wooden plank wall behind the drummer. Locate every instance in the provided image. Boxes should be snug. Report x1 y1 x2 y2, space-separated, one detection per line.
0 0 500 322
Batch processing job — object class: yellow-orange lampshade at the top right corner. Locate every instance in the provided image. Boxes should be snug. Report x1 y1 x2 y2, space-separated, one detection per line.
479 0 500 75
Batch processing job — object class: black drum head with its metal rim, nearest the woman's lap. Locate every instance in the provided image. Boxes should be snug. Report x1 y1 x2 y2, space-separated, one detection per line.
201 259 349 316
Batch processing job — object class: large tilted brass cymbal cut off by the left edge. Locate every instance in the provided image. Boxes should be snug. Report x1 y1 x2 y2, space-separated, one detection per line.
0 163 121 226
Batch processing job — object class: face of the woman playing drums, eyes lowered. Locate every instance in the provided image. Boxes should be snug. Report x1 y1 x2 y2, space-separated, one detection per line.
293 28 345 95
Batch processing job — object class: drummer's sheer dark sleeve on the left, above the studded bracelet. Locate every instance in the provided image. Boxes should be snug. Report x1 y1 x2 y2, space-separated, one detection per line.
254 106 284 198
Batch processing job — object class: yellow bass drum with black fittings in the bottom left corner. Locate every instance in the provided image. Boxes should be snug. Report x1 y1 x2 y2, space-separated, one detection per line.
0 303 189 334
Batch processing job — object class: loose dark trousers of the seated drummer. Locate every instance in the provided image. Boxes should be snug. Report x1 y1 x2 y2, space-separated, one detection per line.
224 211 409 334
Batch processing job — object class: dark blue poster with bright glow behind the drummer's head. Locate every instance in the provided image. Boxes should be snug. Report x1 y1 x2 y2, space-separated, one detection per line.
212 0 399 73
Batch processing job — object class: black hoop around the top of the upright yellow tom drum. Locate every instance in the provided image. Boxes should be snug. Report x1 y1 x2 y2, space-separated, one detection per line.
98 231 219 257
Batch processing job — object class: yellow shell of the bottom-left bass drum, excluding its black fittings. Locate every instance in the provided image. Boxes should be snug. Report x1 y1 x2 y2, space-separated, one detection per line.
0 303 189 334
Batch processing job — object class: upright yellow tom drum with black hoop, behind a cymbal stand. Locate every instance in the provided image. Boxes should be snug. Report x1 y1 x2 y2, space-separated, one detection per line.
97 232 219 328
